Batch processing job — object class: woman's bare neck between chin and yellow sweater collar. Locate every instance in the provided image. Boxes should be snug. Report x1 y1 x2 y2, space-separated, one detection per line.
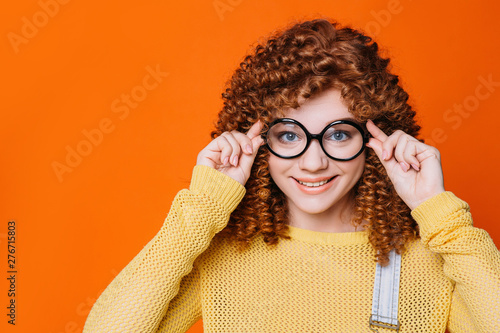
288 194 363 232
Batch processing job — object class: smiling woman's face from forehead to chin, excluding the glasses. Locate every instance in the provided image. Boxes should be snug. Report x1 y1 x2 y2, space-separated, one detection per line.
269 89 365 216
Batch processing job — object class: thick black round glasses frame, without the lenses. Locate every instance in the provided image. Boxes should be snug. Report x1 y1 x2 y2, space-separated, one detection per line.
264 118 370 162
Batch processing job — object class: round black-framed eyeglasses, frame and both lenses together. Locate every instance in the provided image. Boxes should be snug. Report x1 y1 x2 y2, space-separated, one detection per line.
264 118 369 161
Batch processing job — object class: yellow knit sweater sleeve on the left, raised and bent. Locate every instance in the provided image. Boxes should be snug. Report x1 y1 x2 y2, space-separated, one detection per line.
83 166 245 333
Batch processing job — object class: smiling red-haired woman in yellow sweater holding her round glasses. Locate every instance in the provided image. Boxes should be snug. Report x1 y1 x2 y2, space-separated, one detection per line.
84 19 500 332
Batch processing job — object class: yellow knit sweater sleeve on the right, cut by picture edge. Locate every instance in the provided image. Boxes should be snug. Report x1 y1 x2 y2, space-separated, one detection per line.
412 192 500 333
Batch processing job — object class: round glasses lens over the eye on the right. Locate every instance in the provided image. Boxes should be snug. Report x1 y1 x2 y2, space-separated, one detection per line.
322 124 363 159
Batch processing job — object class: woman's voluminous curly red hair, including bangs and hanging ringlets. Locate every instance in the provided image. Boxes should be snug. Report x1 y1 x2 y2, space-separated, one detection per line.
211 19 420 265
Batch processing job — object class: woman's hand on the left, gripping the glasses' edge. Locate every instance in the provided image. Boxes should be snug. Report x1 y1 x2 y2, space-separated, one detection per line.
196 120 264 185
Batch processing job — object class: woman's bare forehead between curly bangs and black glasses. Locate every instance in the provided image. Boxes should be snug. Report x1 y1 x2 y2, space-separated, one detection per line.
284 89 354 131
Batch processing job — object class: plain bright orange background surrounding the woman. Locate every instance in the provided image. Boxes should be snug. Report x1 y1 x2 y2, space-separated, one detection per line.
0 0 500 333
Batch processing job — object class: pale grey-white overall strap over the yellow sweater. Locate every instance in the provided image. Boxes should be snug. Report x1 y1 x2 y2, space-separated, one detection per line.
370 250 401 331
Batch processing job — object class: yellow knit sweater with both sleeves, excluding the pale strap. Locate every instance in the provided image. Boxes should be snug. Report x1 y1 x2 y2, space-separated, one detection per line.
83 166 500 333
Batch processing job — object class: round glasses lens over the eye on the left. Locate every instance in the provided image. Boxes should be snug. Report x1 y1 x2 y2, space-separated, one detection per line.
267 122 307 157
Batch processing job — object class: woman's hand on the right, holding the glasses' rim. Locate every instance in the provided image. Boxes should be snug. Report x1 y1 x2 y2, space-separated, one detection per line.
366 120 445 210
